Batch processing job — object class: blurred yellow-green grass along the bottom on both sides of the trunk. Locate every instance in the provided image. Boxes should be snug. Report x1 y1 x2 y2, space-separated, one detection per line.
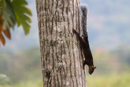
11 73 130 87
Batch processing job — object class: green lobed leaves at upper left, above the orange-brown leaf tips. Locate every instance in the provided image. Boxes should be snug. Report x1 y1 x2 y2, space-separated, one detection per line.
0 0 32 35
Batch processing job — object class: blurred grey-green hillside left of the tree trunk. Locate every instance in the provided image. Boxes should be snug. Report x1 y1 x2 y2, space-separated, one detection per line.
0 47 42 83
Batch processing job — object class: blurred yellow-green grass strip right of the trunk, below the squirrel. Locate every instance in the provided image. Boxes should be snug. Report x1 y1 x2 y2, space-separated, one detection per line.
87 73 130 87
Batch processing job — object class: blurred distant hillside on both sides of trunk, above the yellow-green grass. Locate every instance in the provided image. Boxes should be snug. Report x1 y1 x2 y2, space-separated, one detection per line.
0 46 130 82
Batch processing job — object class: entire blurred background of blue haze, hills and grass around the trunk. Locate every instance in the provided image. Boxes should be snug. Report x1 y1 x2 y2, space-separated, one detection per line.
0 0 130 87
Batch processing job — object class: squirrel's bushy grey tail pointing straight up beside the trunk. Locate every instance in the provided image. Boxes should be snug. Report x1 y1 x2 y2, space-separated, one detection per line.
80 5 88 37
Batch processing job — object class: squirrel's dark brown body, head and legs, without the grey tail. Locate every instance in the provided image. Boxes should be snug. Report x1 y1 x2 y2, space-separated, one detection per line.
73 29 96 74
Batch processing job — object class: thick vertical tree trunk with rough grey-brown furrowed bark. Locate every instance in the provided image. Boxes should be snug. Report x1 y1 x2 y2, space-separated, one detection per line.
36 0 86 87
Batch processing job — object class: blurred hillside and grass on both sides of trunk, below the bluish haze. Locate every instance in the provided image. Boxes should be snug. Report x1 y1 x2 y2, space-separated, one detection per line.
0 46 130 87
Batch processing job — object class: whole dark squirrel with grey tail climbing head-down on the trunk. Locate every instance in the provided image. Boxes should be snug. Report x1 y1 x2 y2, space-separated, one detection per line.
73 5 96 74
